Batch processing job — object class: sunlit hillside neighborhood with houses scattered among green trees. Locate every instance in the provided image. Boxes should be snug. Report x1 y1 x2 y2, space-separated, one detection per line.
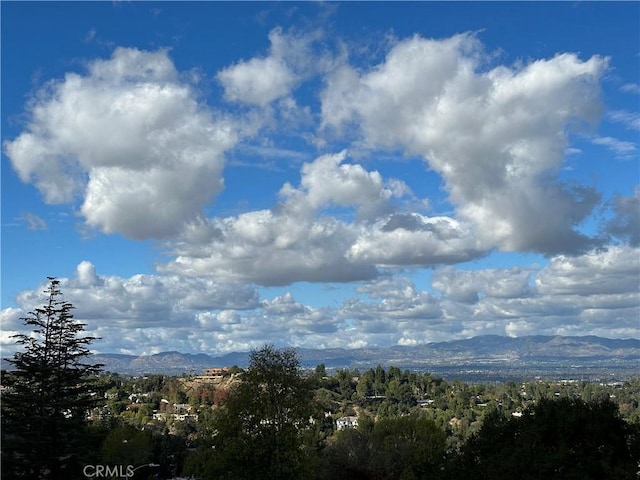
70 358 640 478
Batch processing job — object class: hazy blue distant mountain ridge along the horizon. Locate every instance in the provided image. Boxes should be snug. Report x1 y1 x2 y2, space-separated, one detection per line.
3 335 640 378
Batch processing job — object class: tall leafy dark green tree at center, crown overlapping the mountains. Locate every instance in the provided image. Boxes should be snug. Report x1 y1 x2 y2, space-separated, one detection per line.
190 345 317 479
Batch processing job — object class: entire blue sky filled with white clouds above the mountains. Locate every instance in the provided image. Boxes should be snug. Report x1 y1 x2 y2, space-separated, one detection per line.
0 2 640 354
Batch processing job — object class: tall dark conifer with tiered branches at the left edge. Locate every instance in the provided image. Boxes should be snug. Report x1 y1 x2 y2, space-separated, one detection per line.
2 277 101 480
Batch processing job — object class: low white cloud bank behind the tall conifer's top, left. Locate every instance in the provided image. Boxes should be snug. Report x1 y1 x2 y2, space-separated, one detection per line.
0 261 340 354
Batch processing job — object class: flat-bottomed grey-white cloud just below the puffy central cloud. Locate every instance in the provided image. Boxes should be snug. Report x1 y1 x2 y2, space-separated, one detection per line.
162 210 376 285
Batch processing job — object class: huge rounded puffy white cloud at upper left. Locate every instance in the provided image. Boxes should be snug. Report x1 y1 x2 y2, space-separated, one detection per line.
4 48 237 239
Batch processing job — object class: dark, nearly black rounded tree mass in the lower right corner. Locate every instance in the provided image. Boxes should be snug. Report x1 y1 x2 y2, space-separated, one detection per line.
453 397 640 480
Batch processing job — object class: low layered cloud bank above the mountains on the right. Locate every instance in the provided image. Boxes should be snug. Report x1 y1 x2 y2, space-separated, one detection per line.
339 246 640 345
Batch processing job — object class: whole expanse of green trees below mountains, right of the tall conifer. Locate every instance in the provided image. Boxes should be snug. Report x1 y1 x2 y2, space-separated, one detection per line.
80 362 640 480
